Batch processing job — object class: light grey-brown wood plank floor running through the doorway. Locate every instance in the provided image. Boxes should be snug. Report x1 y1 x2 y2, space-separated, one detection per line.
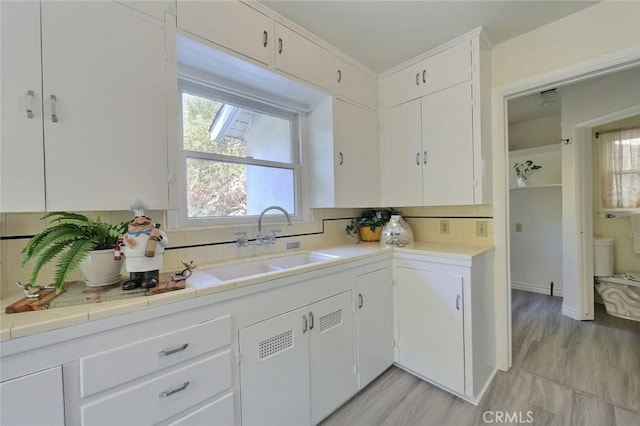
322 290 640 426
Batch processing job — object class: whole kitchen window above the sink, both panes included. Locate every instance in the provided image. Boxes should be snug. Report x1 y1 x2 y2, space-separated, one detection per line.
179 81 300 226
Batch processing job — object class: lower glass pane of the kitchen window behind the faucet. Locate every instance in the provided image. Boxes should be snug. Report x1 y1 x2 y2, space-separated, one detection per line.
187 158 295 218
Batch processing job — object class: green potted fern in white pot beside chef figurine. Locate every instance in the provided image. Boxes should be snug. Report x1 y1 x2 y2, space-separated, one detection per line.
22 212 128 292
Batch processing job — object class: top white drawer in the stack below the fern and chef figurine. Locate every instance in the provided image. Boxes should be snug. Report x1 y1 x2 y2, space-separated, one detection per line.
80 316 231 398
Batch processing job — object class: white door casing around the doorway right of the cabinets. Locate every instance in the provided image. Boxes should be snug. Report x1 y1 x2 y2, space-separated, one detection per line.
492 46 640 371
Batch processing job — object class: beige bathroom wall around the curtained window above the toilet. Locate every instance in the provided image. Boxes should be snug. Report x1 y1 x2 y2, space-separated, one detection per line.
591 115 640 274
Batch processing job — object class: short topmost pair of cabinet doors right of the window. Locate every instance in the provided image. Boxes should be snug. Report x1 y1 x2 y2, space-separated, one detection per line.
381 41 471 108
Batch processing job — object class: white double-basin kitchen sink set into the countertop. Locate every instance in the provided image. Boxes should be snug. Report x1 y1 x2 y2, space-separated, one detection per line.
203 253 336 281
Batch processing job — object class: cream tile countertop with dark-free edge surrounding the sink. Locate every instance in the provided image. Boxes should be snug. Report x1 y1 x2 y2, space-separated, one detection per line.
0 242 493 342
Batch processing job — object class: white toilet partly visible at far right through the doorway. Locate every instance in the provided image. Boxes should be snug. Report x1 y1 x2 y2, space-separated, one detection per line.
593 237 640 321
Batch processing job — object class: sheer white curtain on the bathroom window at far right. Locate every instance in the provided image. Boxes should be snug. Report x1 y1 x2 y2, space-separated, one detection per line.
598 128 640 209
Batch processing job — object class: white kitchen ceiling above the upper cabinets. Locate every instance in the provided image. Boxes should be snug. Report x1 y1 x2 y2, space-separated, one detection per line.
259 0 598 73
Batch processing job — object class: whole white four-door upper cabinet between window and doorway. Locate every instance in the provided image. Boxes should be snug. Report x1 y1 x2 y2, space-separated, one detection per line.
381 35 491 206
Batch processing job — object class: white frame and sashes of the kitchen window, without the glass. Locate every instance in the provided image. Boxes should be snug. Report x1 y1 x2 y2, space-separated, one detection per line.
171 76 305 228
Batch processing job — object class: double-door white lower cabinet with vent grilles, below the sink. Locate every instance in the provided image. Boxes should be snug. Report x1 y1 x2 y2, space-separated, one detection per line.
239 291 356 426
